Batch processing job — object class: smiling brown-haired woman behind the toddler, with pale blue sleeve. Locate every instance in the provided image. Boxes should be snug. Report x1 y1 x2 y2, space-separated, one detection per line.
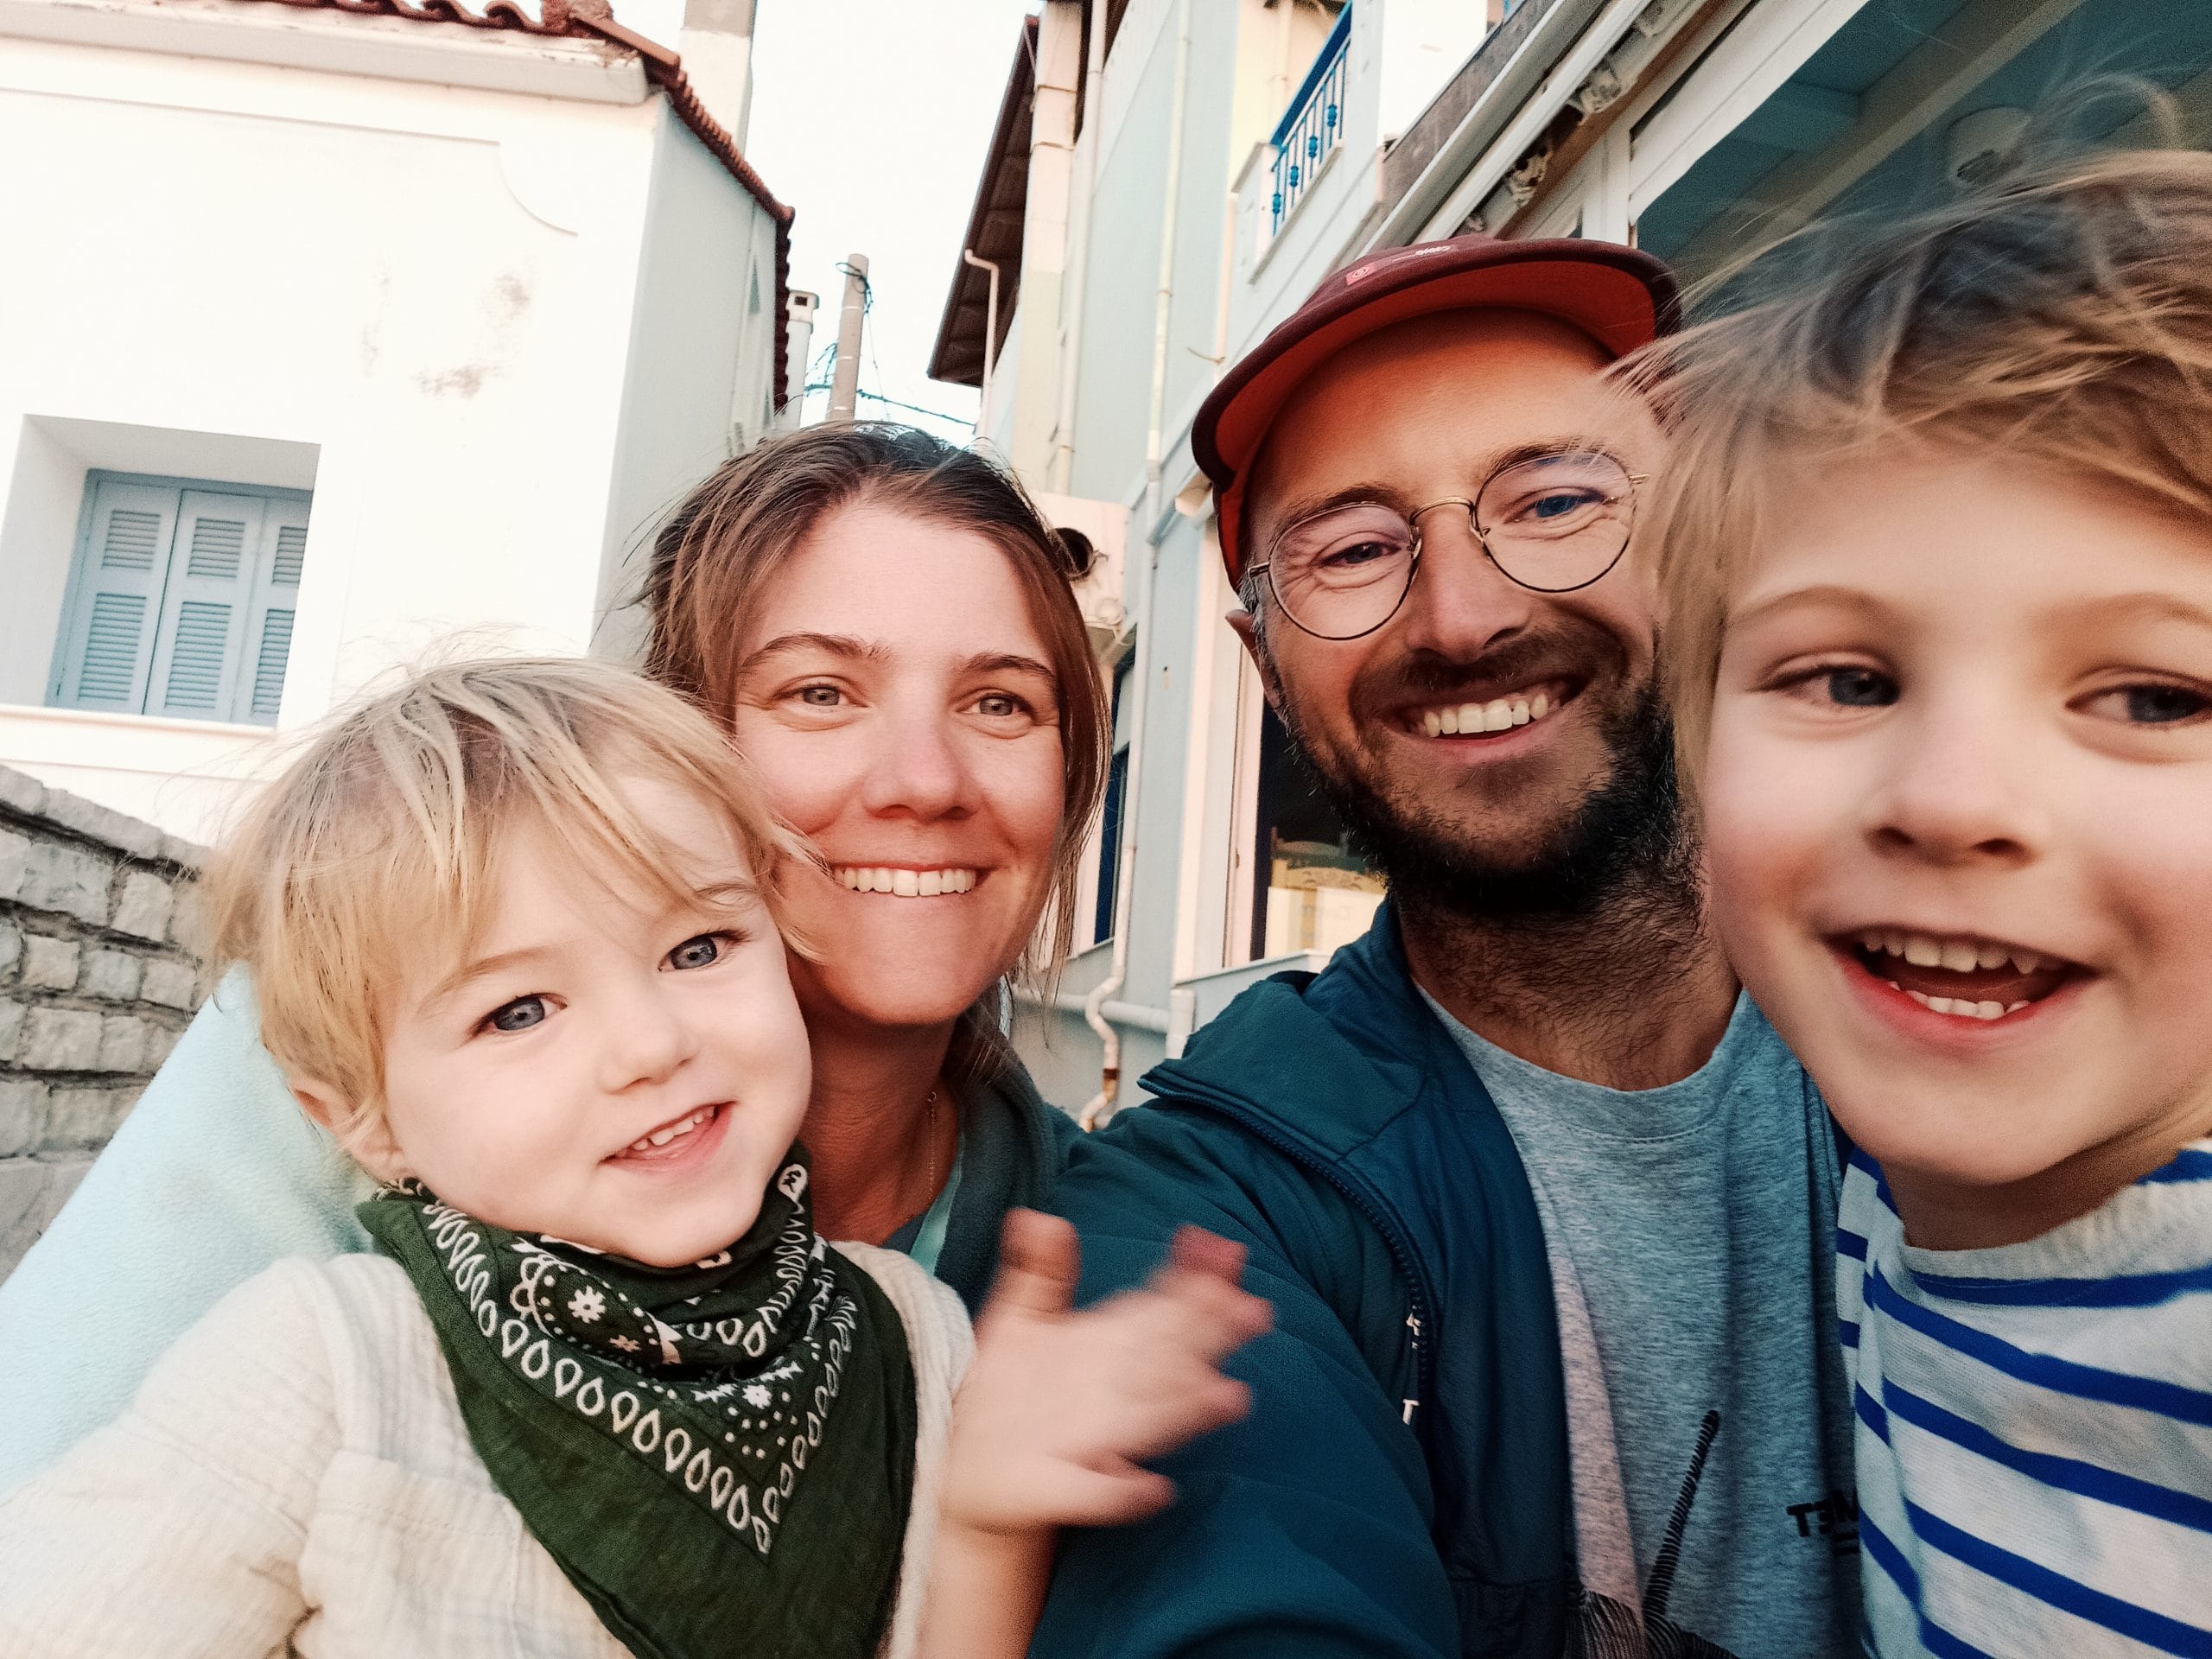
0 425 1103 1491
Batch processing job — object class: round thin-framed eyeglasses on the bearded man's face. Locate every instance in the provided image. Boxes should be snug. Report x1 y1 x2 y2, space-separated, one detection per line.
1252 449 1643 639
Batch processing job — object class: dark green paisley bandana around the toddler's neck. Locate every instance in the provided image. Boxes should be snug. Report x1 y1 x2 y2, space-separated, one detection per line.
360 1146 916 1659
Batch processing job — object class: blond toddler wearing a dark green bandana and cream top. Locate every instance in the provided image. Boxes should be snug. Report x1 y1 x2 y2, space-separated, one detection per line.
0 661 1265 1659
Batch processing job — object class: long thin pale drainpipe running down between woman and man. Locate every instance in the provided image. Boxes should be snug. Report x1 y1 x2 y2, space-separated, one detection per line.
1077 0 1190 1128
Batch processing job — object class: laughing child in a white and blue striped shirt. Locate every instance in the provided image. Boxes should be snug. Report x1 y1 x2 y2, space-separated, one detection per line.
1662 150 2212 1659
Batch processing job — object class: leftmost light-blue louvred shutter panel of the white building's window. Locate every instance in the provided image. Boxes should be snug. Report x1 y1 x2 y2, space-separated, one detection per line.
48 478 179 715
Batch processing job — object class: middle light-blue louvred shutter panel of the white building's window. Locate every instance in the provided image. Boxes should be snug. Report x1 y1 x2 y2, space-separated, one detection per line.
146 489 268 721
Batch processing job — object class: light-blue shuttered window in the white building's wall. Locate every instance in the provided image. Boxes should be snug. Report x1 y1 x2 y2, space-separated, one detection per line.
51 474 309 726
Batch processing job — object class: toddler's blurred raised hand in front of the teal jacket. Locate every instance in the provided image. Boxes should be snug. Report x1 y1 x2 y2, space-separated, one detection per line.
944 1210 1274 1533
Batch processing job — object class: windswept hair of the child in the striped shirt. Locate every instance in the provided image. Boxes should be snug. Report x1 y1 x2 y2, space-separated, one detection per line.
1630 137 2212 781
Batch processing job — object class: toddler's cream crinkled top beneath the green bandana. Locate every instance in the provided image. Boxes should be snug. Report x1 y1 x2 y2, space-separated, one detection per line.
0 1245 973 1659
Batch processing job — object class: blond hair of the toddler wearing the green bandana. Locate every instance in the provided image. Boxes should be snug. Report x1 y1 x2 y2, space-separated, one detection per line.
206 657 810 1146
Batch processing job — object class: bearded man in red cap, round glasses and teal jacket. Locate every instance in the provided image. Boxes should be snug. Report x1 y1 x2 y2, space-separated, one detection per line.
1033 237 1858 1659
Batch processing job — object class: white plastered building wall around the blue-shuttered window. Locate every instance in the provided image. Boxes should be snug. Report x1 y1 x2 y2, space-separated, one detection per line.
0 35 777 836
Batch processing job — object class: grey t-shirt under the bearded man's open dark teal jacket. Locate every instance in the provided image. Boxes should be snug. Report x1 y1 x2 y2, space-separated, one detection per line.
1429 998 1858 1659
